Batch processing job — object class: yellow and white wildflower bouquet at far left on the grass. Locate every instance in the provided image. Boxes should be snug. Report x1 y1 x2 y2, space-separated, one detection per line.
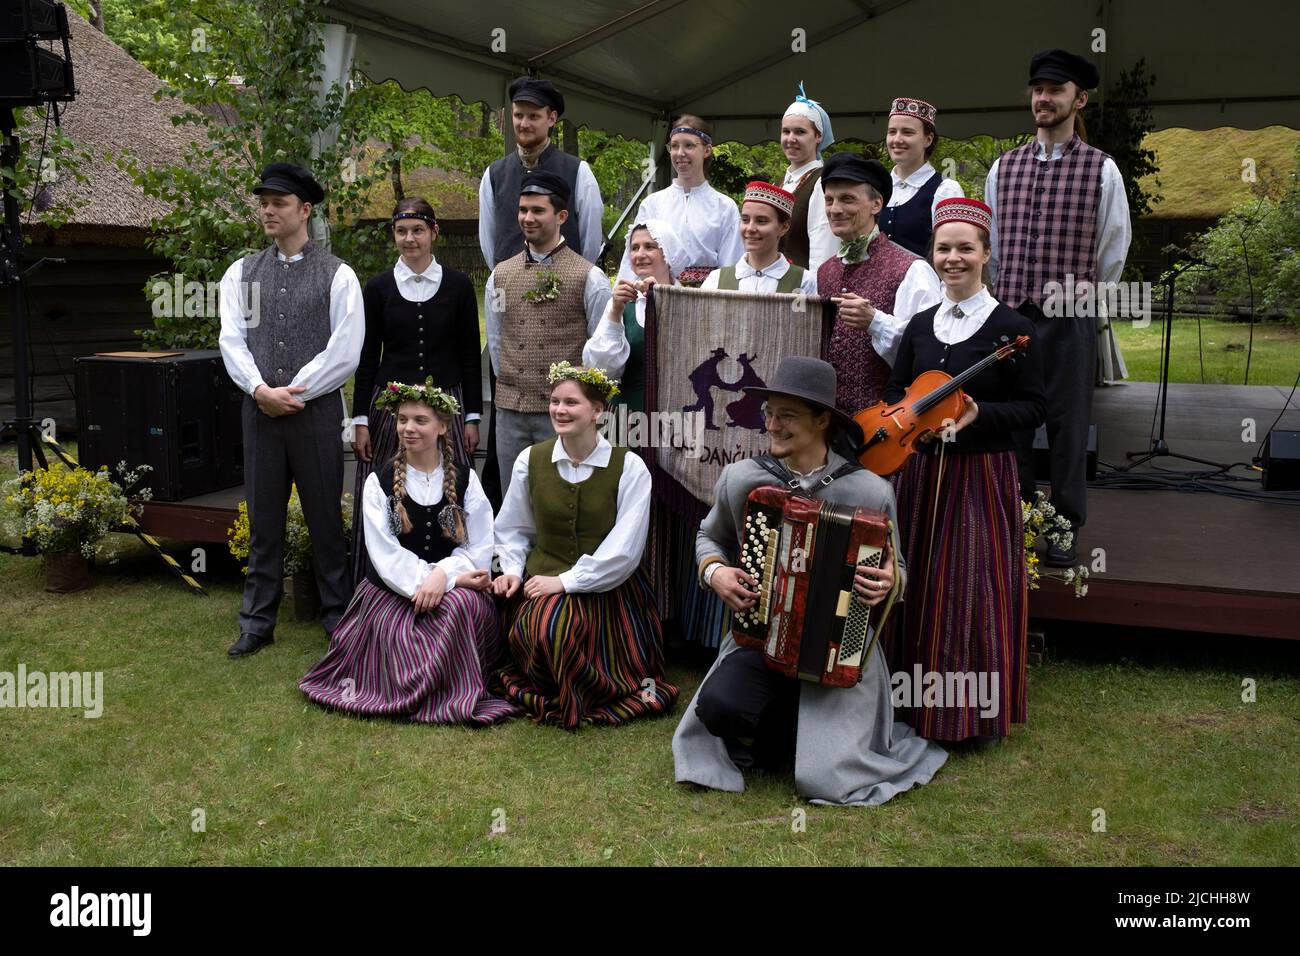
3 462 150 559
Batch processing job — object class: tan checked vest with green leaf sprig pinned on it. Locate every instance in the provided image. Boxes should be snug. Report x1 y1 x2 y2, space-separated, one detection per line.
493 242 592 412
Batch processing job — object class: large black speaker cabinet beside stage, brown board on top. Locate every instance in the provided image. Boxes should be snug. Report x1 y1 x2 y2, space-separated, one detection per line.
75 350 243 501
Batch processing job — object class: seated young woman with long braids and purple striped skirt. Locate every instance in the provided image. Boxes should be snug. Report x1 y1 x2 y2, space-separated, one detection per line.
298 378 519 724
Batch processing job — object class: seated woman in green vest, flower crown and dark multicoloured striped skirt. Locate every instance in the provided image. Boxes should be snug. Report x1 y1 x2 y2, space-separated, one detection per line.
493 362 677 730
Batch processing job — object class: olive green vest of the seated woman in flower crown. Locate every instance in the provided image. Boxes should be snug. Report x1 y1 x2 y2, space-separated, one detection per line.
524 438 628 578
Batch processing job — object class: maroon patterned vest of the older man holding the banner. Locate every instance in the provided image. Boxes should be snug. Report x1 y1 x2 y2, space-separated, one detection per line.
816 233 920 415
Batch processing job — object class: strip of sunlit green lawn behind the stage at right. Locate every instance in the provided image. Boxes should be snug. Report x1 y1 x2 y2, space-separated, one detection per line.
1115 316 1300 388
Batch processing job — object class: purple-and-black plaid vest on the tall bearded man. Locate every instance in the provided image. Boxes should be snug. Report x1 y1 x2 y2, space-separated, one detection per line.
993 134 1108 308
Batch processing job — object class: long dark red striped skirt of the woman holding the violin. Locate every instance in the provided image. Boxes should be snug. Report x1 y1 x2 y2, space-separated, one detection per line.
887 451 1028 740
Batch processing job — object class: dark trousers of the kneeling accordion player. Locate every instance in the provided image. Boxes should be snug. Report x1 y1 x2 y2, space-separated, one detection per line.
696 648 800 769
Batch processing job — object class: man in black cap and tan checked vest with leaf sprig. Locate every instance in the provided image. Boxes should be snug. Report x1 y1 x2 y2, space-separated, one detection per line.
484 169 611 493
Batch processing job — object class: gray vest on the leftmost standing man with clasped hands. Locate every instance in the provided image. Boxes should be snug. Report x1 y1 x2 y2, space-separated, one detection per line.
242 241 343 388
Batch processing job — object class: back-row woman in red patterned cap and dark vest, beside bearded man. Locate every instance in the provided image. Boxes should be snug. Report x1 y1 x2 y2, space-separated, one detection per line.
880 96 966 256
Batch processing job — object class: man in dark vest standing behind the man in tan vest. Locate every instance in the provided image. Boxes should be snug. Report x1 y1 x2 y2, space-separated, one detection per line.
478 77 605 269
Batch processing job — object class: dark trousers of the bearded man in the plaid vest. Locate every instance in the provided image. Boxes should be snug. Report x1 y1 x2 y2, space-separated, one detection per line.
1013 302 1097 531
